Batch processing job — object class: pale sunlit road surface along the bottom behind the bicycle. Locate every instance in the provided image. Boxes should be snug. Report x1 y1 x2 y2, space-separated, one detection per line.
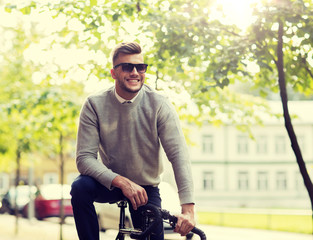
0 214 313 240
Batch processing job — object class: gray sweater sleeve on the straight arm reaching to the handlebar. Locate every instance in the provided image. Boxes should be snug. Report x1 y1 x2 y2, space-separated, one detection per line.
157 99 194 204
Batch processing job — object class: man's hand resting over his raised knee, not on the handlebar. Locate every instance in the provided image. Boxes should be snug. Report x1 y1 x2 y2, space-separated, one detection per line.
112 176 148 210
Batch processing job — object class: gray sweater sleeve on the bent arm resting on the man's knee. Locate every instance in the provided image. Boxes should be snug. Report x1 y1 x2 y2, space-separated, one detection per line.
76 99 118 189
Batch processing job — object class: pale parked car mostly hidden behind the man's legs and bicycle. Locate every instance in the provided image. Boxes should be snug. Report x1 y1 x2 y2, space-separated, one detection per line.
95 182 192 239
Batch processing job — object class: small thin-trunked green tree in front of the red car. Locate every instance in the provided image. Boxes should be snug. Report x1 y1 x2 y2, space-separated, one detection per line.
31 86 81 240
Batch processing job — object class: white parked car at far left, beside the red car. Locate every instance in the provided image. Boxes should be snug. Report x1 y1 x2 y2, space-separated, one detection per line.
0 185 37 214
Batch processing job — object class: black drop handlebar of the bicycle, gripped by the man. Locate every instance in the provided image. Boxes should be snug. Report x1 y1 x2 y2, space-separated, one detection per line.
130 204 206 240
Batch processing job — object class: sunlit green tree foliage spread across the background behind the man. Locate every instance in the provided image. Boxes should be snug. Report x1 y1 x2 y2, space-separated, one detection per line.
0 0 313 171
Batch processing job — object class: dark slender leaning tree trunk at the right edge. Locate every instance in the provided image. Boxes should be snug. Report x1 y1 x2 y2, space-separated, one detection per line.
276 18 313 234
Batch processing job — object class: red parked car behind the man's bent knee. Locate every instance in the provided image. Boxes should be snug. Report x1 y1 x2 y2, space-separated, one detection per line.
23 184 73 220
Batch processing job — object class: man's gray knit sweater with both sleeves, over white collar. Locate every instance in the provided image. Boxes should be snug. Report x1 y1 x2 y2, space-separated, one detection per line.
76 85 194 204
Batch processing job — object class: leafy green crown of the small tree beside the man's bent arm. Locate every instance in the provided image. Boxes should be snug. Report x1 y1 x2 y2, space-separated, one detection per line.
30 87 81 158
